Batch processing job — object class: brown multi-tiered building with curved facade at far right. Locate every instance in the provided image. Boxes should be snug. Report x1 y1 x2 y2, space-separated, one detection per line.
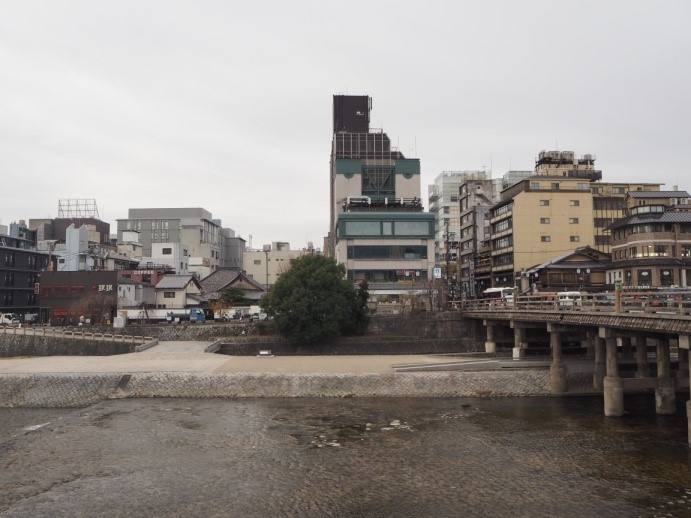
607 191 691 288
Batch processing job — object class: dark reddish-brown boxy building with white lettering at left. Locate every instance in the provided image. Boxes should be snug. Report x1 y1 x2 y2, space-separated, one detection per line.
40 271 118 325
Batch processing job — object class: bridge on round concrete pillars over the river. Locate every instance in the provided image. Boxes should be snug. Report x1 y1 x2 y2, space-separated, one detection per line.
460 291 691 445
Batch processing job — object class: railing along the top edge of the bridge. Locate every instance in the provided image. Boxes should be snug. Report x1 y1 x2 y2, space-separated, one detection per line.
458 290 691 316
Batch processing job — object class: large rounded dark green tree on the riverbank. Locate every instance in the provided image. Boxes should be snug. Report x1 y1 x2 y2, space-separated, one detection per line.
260 255 369 343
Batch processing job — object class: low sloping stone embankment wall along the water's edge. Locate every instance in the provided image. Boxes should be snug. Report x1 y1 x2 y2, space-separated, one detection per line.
0 370 549 407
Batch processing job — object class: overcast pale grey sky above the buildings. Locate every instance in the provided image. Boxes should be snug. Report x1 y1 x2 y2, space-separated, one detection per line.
0 0 691 248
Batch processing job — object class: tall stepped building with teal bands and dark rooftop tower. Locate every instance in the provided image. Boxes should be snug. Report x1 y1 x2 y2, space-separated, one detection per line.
327 95 434 295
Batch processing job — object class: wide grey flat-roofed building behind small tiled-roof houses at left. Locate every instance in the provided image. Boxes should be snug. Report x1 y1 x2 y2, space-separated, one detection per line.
117 207 245 278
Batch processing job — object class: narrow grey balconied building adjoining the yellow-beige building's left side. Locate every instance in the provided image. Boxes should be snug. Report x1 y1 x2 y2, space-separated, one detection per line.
457 179 497 297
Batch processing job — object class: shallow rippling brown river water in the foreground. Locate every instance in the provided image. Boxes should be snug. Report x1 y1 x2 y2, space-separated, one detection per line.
0 396 691 517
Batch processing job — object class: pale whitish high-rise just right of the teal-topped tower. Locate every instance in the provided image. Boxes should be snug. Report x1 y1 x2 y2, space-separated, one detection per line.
427 171 490 265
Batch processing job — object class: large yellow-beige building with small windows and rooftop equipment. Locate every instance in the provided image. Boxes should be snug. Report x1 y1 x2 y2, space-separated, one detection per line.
490 151 660 286
